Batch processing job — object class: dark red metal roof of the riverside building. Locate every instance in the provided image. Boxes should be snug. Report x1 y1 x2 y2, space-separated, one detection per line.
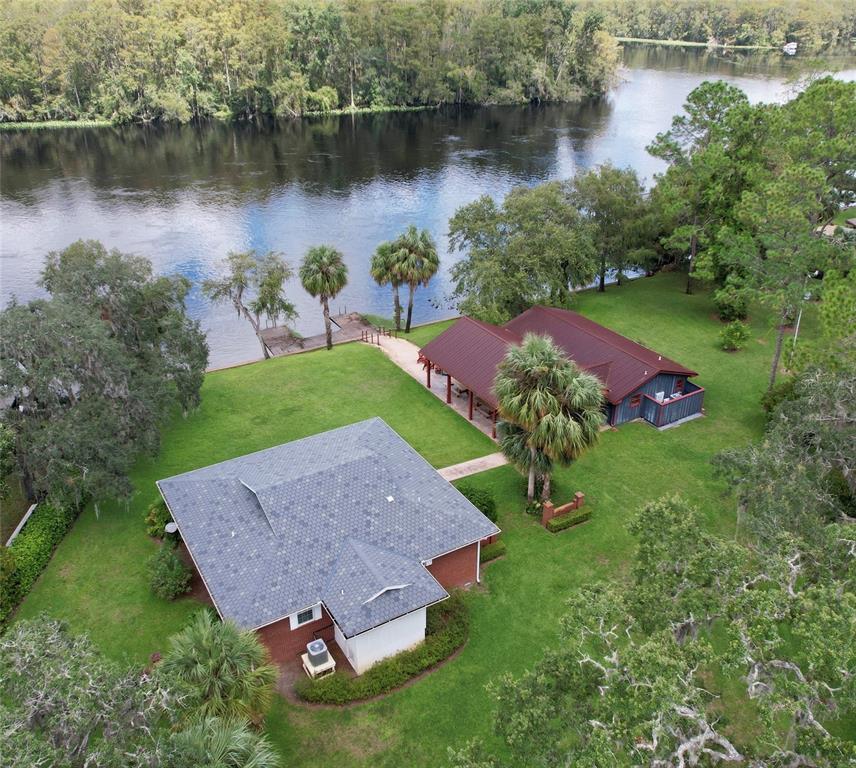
421 307 698 407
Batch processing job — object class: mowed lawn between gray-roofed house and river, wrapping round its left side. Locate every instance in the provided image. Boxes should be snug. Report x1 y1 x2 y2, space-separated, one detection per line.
19 344 495 662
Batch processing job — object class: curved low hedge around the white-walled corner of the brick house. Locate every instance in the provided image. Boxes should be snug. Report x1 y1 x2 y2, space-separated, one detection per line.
294 593 470 704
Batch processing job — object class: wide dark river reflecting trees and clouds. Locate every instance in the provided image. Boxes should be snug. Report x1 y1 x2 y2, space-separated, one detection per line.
0 45 856 366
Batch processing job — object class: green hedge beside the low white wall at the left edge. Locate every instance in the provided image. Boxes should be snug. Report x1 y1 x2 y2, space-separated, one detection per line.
0 502 78 626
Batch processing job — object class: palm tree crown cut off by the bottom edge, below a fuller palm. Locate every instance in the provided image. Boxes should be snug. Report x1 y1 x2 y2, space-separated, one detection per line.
167 717 281 768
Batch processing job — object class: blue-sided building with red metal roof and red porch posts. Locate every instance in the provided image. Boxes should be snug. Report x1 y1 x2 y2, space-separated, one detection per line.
419 306 704 436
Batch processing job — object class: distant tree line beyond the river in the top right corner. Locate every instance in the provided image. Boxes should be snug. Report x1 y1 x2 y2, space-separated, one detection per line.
583 0 856 48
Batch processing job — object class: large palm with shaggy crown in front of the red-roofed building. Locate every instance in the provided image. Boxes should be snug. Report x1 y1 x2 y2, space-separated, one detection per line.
494 333 603 501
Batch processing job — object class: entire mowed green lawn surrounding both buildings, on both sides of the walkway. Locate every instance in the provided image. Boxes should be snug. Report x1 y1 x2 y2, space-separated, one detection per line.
22 274 813 766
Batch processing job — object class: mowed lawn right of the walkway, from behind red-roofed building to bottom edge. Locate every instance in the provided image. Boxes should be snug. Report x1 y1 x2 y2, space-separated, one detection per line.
268 275 813 768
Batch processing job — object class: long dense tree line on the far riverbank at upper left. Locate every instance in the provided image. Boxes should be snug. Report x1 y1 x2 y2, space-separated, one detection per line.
0 0 618 122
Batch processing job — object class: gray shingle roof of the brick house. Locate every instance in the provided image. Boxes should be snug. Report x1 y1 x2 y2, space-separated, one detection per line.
158 418 498 637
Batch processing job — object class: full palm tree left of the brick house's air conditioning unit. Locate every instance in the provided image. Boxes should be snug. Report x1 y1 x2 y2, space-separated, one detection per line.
160 610 277 724
